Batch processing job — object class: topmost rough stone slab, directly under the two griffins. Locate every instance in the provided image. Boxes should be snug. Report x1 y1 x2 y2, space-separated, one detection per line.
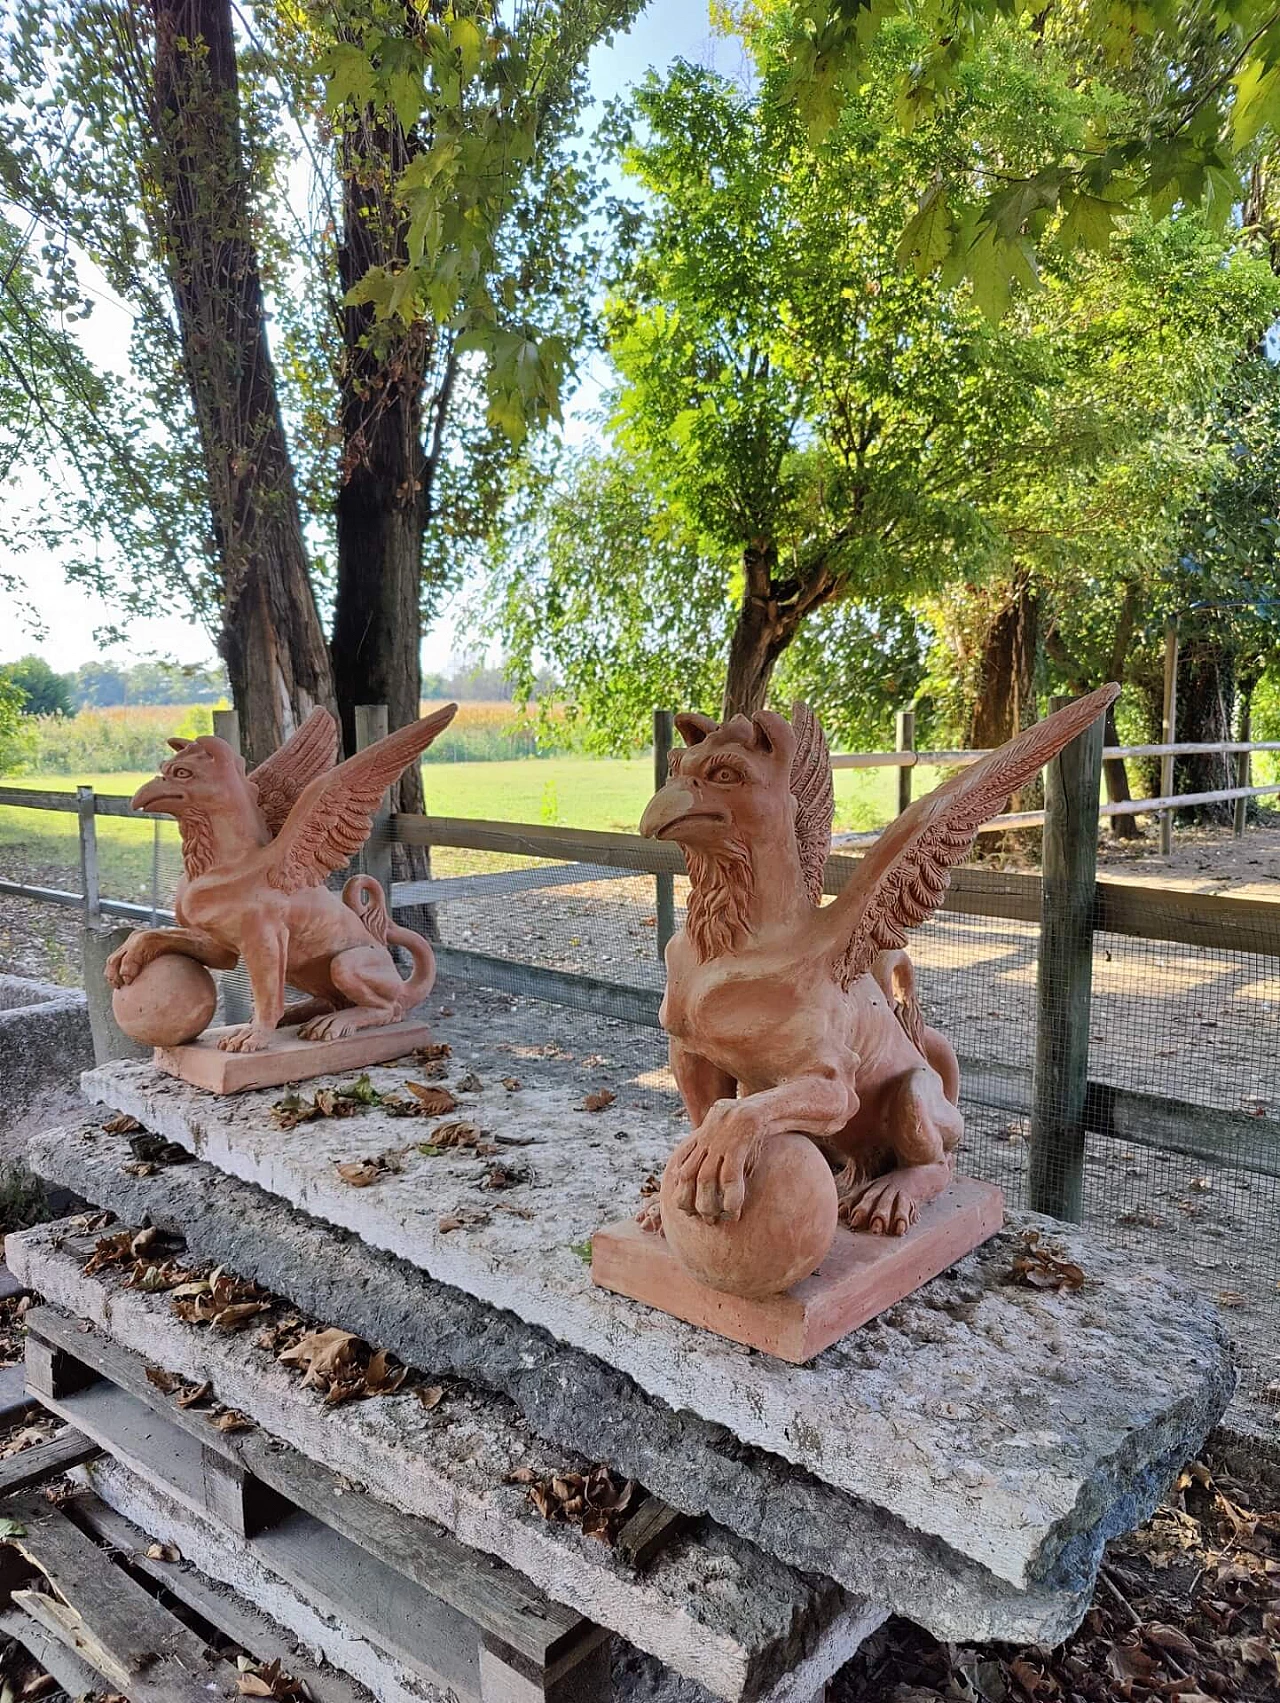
82 1055 1234 1587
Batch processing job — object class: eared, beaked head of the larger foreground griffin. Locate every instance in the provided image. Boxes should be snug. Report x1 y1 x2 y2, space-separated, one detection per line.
640 710 797 852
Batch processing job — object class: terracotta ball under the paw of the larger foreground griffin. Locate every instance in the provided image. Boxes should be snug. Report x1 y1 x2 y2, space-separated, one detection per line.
660 1134 837 1299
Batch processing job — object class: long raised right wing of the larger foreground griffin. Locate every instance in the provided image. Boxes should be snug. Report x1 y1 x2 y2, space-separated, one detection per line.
822 686 1120 988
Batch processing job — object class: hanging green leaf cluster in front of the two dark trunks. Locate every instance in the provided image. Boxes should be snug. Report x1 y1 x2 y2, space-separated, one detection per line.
318 0 643 443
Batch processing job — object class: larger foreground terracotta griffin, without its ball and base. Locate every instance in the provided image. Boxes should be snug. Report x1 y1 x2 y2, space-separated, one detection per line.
640 686 1120 1236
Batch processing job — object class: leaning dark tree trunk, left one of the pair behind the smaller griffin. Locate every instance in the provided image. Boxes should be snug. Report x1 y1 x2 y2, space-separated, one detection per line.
151 0 334 763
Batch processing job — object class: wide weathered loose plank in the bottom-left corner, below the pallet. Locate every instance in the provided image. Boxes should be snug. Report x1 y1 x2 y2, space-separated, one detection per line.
7 1495 237 1703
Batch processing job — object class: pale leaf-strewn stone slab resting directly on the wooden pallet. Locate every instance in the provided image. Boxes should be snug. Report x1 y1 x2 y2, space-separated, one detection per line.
5 1224 885 1703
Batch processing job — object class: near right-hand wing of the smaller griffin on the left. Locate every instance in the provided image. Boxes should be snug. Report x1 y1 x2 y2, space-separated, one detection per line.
267 703 458 892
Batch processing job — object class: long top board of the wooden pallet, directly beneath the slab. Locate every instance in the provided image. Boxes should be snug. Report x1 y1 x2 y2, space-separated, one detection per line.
27 1306 591 1666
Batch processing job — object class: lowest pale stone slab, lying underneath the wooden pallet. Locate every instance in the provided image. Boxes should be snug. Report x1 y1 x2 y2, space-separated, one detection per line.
75 1456 789 1703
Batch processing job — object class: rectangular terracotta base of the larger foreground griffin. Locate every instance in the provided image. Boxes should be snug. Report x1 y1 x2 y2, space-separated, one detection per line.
591 1177 1004 1366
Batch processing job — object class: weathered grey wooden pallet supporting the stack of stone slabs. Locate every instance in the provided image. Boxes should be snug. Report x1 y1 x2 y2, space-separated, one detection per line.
26 1306 609 1703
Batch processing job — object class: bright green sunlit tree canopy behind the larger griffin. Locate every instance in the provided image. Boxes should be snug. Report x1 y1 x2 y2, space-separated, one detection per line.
494 16 1280 748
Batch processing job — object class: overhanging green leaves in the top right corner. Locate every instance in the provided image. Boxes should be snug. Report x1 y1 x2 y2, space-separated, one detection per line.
737 0 1280 315
